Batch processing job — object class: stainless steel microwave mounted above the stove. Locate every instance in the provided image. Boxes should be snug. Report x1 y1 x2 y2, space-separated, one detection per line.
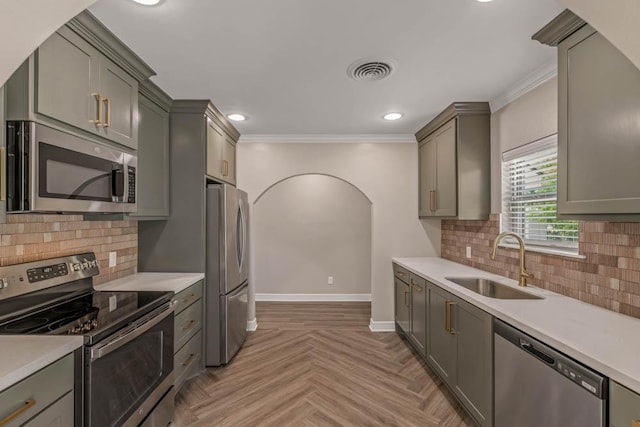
6 121 137 213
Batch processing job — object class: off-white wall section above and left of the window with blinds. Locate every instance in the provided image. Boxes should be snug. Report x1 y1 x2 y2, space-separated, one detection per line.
491 77 558 213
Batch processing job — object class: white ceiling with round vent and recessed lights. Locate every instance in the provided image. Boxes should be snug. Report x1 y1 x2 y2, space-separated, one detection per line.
90 0 563 135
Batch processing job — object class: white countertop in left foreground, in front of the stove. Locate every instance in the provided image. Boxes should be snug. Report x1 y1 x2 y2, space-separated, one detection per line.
0 335 83 391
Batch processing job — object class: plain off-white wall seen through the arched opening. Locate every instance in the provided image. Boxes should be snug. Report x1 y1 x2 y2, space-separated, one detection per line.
252 174 371 295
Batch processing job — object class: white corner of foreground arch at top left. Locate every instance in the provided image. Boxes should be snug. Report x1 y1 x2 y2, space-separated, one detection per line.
0 0 96 86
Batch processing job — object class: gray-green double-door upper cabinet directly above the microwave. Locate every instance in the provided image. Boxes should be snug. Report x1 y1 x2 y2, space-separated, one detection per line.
6 11 154 149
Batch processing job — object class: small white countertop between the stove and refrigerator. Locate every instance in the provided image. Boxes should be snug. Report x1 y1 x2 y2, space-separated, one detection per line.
95 273 204 294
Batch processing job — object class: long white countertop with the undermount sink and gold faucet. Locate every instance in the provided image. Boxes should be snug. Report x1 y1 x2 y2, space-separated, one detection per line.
393 257 640 393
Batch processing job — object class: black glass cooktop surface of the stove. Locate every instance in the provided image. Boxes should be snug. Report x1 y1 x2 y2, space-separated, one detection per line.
0 291 173 343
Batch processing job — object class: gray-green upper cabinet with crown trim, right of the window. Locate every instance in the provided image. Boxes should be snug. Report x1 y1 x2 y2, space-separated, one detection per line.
534 10 640 221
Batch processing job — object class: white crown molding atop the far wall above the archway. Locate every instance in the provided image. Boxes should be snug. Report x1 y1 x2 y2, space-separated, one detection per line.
238 134 416 144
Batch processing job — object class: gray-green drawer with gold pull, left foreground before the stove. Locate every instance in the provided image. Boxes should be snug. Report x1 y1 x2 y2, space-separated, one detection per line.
0 354 74 426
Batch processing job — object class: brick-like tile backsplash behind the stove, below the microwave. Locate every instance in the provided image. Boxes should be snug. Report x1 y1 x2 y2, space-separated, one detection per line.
0 214 138 285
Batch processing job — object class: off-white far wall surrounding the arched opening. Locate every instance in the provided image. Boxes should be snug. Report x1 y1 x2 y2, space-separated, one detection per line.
237 143 440 321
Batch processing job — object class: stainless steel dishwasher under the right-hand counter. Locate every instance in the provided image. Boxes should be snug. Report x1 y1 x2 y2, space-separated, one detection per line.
494 319 608 427
